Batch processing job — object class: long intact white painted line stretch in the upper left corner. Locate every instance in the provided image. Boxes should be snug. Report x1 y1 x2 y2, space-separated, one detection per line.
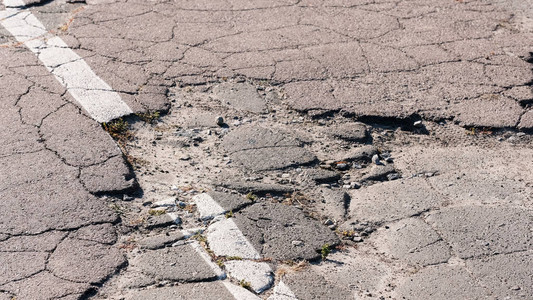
0 0 133 122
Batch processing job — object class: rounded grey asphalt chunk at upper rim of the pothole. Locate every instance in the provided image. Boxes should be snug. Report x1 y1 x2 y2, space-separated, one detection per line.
212 82 267 113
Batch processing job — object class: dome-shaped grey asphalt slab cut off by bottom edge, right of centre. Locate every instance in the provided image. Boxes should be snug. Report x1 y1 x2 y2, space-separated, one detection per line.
393 264 489 300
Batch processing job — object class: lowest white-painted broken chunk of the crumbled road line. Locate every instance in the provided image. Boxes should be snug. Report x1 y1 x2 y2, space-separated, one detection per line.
224 260 274 294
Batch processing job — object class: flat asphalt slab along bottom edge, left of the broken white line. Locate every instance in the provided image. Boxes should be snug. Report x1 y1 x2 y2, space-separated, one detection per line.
126 281 234 300
